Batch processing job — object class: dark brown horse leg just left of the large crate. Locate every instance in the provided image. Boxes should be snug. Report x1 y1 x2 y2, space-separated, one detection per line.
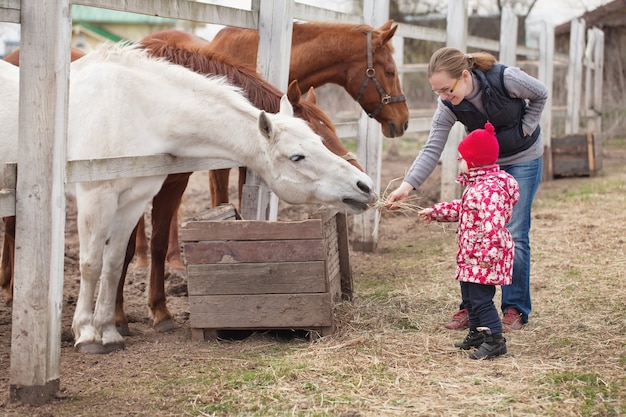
148 173 191 333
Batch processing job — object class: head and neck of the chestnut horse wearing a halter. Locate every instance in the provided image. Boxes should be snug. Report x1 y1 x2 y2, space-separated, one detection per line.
207 20 409 138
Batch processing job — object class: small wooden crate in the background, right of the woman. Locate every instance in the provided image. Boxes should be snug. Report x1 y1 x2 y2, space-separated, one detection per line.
551 133 597 178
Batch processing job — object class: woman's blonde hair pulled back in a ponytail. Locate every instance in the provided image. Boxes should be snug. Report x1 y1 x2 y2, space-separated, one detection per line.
428 47 497 78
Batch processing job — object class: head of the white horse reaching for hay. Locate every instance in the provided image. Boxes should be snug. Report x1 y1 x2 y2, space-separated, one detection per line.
259 95 376 213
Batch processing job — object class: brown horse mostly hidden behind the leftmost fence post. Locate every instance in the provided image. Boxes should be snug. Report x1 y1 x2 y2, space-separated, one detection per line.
0 48 85 305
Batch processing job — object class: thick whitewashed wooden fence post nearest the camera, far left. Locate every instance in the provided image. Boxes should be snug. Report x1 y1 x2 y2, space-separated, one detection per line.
9 0 72 404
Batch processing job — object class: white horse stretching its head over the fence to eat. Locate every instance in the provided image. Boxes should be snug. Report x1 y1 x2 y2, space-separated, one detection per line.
0 45 375 353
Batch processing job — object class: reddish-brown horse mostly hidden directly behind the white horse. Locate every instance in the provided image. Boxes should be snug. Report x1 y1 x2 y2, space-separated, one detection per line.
115 37 362 334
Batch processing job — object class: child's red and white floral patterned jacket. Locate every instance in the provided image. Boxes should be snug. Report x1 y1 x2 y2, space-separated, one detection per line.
424 165 519 285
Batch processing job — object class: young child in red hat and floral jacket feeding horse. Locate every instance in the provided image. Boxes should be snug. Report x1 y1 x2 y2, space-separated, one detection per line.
418 123 520 359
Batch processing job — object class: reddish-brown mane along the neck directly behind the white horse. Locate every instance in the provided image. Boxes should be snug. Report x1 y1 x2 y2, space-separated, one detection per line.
140 38 283 113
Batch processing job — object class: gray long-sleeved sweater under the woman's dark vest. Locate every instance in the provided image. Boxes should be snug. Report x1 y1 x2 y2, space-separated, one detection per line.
404 67 548 189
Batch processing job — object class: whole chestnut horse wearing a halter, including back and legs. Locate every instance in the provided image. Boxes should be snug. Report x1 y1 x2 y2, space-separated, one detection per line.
135 20 409 270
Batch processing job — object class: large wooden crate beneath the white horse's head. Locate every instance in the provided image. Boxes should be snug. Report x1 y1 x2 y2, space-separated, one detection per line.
181 213 352 340
